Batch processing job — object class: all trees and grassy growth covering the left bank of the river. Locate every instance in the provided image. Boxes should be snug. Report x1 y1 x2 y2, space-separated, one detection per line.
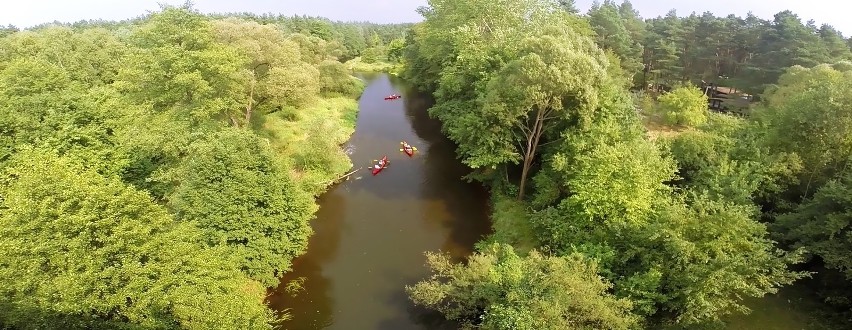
0 4 376 329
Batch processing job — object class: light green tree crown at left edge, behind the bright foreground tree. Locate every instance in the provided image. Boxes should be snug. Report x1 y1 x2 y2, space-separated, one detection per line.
0 58 122 172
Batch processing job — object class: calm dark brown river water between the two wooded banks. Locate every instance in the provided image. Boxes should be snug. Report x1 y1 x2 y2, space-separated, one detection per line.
268 74 490 330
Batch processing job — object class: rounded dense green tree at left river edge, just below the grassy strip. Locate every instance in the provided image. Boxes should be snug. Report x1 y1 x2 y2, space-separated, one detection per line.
160 129 316 286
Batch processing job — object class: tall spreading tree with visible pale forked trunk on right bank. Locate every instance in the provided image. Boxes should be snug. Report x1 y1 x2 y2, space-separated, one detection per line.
407 0 609 199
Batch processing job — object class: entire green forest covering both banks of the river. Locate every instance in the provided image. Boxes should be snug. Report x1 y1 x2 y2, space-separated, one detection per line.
0 0 852 329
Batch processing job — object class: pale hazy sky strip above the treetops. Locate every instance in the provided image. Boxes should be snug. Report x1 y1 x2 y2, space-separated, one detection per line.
0 0 852 36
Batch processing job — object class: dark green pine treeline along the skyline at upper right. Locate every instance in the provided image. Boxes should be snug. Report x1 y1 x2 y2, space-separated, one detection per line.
587 0 852 94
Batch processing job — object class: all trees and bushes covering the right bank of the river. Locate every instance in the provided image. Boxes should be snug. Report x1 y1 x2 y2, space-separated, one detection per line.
402 0 852 329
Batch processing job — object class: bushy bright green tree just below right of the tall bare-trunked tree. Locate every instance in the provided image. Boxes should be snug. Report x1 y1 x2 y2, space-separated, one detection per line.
534 114 675 227
